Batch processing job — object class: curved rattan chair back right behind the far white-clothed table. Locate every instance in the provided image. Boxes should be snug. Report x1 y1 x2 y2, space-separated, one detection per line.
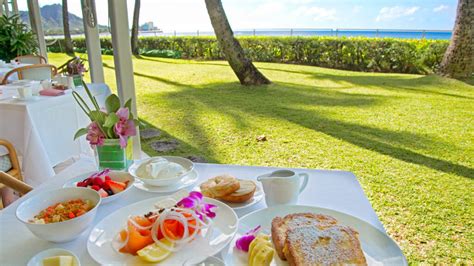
1 64 58 85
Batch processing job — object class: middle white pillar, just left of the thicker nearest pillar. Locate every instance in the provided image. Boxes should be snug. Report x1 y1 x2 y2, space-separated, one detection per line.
81 0 104 83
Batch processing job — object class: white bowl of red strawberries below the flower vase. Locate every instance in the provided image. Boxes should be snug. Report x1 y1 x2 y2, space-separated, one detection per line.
63 170 135 204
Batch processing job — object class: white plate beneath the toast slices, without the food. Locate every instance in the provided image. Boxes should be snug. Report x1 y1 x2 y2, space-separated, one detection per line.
223 205 407 265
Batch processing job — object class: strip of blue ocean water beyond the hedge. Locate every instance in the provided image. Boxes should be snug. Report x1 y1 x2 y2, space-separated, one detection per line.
140 29 451 40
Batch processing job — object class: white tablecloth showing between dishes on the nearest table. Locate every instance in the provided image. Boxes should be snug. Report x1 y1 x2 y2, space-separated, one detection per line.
0 159 385 265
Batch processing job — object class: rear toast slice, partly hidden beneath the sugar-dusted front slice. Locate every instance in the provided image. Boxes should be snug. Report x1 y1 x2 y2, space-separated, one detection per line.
272 213 337 260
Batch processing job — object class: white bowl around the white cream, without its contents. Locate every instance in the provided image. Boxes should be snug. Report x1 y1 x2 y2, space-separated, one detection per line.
128 156 194 187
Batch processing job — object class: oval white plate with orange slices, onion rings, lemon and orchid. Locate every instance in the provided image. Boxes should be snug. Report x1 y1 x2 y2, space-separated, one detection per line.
87 191 238 265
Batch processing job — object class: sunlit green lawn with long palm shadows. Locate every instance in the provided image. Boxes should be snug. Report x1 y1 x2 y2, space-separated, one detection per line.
50 54 474 263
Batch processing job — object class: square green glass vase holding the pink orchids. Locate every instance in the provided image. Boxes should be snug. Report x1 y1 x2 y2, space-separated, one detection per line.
96 138 133 170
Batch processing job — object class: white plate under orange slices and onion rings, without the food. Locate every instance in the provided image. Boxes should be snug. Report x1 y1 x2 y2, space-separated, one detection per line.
87 194 238 265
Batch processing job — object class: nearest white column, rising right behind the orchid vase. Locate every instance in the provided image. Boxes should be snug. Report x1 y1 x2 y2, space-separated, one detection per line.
108 0 141 159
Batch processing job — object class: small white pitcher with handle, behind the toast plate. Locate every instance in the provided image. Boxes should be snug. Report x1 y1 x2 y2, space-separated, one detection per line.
257 170 309 207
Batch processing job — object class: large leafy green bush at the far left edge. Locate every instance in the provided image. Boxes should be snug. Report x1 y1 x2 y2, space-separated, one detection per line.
0 15 38 61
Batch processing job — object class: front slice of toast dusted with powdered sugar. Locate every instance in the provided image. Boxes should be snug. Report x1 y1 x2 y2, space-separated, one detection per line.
283 225 367 266
